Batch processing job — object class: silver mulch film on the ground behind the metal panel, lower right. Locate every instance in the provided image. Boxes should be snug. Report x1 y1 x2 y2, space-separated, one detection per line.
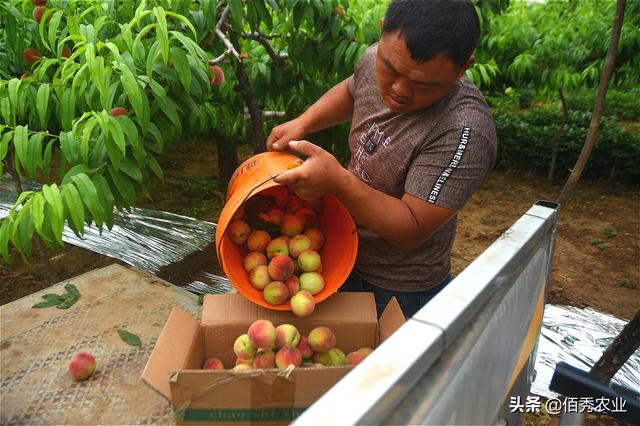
531 304 640 398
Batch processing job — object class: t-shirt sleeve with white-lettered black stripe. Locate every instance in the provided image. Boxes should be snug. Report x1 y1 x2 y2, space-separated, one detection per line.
404 124 496 210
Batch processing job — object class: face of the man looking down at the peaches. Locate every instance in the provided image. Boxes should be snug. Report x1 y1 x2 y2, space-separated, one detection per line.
376 31 473 113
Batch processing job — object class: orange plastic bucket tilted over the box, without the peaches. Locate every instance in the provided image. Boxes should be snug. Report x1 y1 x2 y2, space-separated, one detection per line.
216 152 358 310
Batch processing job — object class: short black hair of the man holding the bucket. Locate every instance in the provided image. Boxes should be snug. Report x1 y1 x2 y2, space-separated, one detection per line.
382 0 480 67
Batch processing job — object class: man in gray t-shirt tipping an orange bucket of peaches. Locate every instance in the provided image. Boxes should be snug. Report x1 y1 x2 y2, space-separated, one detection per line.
267 0 496 318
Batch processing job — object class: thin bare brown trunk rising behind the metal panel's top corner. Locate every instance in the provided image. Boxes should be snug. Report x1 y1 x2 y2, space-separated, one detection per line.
558 0 626 208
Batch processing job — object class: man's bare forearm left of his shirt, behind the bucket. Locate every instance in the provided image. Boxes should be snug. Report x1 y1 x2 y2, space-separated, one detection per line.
298 80 353 134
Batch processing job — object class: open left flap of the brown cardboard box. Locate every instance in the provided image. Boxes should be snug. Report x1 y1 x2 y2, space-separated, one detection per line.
142 308 202 399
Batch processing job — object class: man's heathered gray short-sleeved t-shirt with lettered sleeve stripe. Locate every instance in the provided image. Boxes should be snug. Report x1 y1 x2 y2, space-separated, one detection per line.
348 45 496 291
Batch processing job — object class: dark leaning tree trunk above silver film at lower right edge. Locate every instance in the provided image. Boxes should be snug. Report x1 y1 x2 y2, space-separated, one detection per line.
589 311 640 380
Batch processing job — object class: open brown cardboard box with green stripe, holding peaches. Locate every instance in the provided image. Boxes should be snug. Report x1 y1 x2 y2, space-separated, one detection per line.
142 293 404 424
